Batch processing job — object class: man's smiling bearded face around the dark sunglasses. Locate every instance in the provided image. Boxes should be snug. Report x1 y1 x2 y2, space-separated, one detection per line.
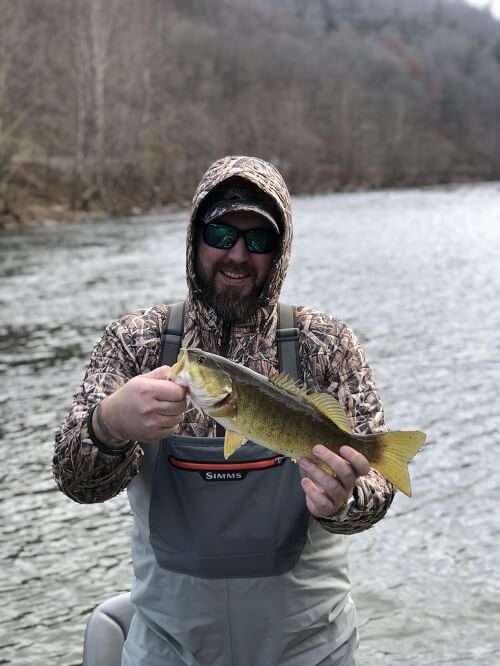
196 211 274 321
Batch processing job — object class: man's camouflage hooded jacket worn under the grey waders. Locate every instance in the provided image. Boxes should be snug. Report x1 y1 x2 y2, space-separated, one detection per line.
53 157 394 534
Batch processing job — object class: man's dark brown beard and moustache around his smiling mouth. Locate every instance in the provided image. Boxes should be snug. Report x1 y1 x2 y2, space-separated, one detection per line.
198 263 262 323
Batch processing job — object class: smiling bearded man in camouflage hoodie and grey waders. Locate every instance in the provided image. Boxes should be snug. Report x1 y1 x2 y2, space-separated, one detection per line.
54 157 394 666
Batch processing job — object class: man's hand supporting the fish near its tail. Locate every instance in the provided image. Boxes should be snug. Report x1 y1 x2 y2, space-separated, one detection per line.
299 444 370 518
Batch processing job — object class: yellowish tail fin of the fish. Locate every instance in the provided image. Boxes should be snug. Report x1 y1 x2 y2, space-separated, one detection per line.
372 431 425 497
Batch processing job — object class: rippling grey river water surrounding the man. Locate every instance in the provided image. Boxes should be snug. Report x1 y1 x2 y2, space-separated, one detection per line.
0 183 500 666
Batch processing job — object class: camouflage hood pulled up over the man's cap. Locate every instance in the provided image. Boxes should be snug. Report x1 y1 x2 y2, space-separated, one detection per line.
186 156 292 316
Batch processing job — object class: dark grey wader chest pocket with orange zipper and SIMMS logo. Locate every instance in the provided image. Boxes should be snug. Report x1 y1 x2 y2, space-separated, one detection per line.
149 435 309 578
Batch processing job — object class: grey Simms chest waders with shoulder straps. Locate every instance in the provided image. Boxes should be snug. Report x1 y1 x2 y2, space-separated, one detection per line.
122 303 357 666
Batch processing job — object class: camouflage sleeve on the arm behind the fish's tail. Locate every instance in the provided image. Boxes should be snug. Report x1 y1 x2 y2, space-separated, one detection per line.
319 326 395 534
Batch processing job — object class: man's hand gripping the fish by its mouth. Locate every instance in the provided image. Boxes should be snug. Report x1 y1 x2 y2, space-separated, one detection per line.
92 365 187 448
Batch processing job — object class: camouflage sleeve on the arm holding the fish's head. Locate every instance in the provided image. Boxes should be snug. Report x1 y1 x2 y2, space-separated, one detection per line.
52 310 166 504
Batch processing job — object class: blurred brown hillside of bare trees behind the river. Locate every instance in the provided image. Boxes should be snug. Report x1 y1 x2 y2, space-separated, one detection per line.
0 0 500 224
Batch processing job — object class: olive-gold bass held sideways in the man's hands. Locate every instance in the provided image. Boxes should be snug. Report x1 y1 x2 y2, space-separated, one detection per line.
169 348 426 497
